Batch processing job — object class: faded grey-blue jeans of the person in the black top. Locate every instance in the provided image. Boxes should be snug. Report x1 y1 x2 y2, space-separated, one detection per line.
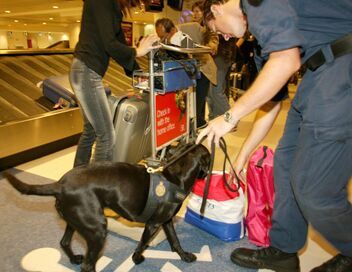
70 58 115 167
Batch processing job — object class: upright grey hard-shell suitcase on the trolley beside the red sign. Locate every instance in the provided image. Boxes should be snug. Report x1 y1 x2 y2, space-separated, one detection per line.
109 93 152 163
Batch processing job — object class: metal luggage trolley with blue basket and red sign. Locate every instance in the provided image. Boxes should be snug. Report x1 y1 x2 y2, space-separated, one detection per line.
133 44 211 167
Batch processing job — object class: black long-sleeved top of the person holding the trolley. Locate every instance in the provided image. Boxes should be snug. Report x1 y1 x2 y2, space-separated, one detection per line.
74 0 136 77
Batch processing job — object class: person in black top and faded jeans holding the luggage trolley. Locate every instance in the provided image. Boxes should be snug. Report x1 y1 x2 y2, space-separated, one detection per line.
70 0 159 167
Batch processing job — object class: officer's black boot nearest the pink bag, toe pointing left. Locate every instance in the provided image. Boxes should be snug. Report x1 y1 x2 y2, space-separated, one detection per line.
231 247 300 272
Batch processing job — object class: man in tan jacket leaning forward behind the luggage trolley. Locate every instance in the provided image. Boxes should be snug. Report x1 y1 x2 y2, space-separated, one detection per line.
155 18 218 127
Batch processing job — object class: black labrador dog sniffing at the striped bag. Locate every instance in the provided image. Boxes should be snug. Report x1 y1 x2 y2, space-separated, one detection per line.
4 145 210 272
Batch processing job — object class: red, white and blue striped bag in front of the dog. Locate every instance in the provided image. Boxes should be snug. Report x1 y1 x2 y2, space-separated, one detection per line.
185 171 245 242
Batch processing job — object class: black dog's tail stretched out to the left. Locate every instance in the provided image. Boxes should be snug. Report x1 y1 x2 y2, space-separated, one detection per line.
3 172 61 196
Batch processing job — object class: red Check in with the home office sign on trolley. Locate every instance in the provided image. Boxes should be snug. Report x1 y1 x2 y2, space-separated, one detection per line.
155 91 188 149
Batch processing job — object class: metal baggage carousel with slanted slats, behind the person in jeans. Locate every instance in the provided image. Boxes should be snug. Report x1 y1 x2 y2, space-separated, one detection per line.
0 49 148 171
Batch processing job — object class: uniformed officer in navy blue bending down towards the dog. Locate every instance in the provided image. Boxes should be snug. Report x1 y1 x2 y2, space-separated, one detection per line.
198 0 352 272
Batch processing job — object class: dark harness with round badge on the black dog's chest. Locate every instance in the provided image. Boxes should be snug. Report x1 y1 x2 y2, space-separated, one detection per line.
136 173 187 222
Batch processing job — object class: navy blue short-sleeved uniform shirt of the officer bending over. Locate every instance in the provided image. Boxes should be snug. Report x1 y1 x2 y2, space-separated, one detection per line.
242 0 352 61
